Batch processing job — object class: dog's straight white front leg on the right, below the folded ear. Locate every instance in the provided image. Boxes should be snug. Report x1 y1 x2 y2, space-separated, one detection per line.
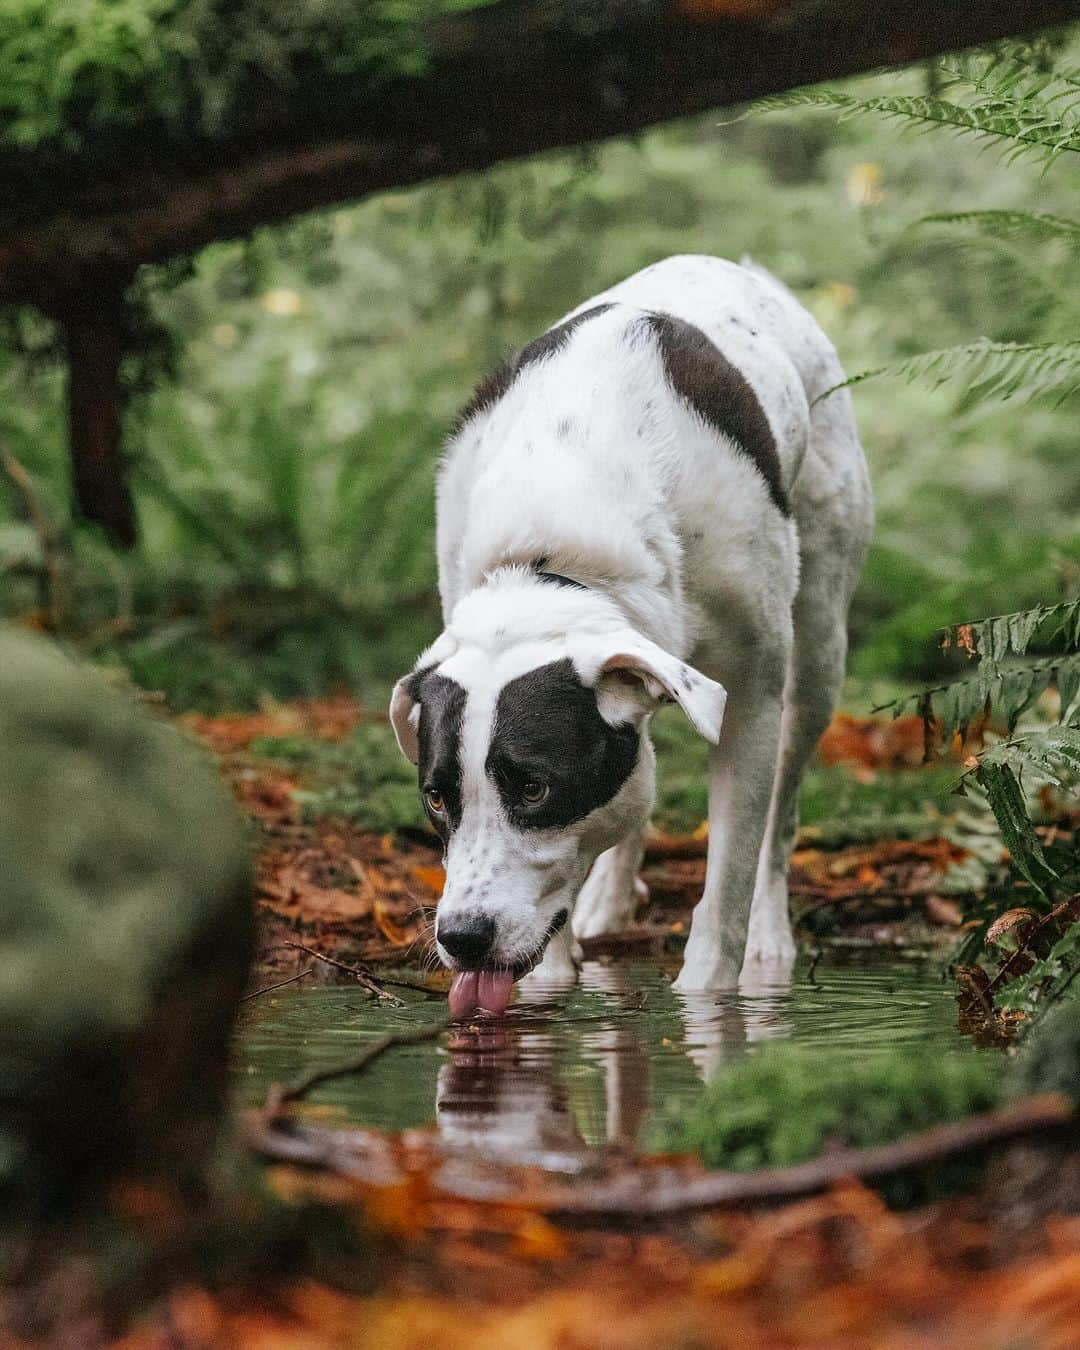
675 678 782 990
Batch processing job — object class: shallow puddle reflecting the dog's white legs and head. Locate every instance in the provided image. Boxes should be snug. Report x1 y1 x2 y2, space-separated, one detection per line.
235 953 973 1169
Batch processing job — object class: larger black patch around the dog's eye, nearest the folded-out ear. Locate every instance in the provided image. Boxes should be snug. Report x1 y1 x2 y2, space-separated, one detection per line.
485 660 639 829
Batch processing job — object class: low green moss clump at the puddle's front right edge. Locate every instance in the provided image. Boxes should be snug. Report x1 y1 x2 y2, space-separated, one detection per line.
659 1042 1002 1172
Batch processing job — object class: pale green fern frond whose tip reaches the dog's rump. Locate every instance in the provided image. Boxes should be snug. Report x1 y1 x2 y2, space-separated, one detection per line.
814 338 1080 406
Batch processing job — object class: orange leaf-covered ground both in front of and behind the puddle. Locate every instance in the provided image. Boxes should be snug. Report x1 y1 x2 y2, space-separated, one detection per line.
59 698 1063 1350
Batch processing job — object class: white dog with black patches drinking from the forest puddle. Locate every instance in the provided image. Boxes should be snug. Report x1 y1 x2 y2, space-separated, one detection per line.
390 257 872 1015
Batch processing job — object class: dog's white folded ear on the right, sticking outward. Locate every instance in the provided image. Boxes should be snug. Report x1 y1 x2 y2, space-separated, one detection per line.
578 630 728 745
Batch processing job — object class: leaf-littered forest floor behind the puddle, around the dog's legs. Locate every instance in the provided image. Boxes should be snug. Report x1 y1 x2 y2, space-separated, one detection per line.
185 697 968 990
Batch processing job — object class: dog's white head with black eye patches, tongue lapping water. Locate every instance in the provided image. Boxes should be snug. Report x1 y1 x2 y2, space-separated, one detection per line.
390 582 725 1010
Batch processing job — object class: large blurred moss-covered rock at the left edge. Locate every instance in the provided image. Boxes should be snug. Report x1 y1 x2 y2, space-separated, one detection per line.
0 628 252 1214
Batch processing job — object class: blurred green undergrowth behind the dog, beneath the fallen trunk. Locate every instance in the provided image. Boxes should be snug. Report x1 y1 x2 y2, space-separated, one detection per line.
0 69 1080 710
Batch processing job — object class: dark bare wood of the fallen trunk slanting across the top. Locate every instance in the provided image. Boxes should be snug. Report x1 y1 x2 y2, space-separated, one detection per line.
0 0 1080 304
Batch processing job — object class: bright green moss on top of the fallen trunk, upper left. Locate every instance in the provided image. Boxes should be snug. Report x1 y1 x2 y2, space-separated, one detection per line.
0 0 487 150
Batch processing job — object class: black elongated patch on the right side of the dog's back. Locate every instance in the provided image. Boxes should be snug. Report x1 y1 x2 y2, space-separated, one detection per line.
645 312 791 516
